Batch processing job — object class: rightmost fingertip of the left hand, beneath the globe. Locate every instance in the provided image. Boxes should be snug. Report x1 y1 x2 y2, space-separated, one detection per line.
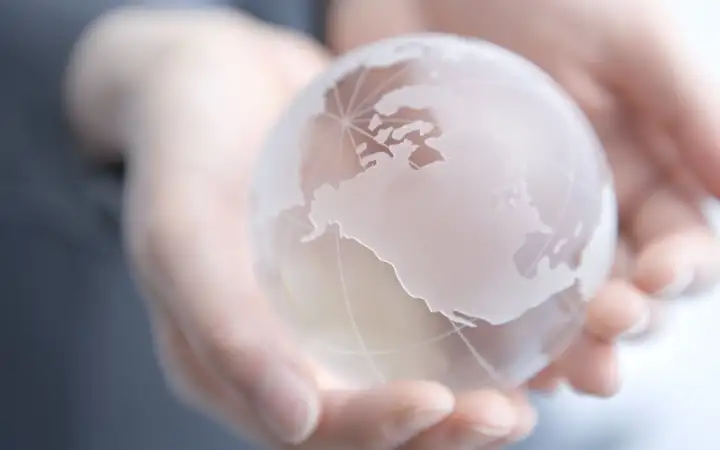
400 390 535 450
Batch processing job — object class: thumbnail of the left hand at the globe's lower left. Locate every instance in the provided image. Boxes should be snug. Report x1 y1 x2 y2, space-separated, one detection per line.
255 369 320 444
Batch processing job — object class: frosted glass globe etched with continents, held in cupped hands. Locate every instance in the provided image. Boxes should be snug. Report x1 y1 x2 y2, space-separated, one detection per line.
251 34 617 390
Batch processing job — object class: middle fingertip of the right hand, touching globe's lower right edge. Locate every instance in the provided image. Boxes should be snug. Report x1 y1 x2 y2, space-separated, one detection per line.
585 279 650 342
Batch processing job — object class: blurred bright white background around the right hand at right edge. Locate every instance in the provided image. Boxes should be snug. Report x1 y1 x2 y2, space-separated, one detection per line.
513 0 720 450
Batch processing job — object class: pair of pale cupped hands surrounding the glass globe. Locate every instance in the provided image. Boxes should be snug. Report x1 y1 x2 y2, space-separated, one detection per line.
67 0 720 450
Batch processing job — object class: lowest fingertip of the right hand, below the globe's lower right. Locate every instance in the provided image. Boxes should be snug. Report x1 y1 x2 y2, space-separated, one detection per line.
557 334 620 397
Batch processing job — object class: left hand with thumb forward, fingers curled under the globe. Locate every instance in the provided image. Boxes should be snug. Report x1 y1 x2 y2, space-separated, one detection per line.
69 10 534 450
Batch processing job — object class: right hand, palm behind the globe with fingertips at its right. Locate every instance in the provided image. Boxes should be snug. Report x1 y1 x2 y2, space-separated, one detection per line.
329 0 720 408
